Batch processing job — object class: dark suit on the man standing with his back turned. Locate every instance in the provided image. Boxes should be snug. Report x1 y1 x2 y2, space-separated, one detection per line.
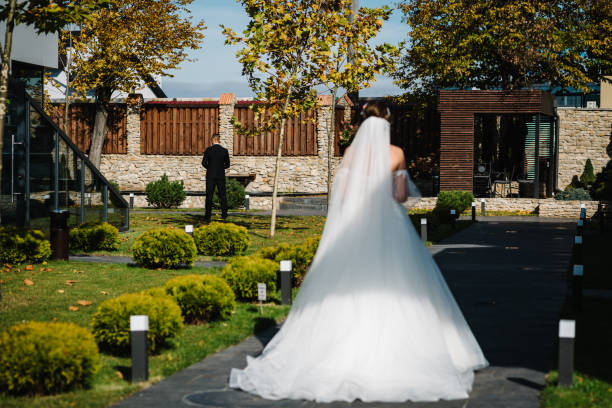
202 144 229 219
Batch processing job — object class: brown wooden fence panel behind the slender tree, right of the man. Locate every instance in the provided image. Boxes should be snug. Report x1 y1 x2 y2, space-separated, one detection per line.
234 102 317 156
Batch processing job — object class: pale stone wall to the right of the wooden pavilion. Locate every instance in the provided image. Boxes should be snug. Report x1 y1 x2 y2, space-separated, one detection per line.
557 108 612 186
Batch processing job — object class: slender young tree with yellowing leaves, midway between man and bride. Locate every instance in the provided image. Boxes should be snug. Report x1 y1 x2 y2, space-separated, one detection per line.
222 0 350 236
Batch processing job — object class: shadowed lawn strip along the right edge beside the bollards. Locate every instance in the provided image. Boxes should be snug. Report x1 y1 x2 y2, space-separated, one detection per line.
541 224 612 408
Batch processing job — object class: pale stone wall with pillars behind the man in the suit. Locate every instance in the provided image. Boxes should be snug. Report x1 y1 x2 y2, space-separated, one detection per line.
100 94 348 194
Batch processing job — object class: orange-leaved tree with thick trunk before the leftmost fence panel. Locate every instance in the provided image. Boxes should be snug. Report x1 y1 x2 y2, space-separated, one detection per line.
68 0 206 167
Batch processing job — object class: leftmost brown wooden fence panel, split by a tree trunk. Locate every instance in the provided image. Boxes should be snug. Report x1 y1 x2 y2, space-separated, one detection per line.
51 103 127 154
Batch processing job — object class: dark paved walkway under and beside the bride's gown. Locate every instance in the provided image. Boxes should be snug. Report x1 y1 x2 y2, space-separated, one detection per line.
111 217 574 408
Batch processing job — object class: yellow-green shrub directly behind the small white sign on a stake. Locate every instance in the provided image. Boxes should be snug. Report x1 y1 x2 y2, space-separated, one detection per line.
221 256 278 300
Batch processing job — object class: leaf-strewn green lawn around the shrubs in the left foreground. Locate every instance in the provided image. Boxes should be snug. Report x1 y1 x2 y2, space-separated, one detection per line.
0 261 288 408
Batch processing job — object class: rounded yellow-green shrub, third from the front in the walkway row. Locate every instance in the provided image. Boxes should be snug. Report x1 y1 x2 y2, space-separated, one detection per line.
165 275 236 323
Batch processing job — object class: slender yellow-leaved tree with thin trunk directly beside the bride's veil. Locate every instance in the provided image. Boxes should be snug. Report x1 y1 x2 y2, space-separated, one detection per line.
315 0 398 204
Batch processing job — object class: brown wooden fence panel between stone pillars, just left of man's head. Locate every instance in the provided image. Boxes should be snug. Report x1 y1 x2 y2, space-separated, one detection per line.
140 102 219 156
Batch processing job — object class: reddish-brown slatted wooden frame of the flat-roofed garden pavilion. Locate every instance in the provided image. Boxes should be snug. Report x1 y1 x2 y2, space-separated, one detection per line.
438 90 556 197
